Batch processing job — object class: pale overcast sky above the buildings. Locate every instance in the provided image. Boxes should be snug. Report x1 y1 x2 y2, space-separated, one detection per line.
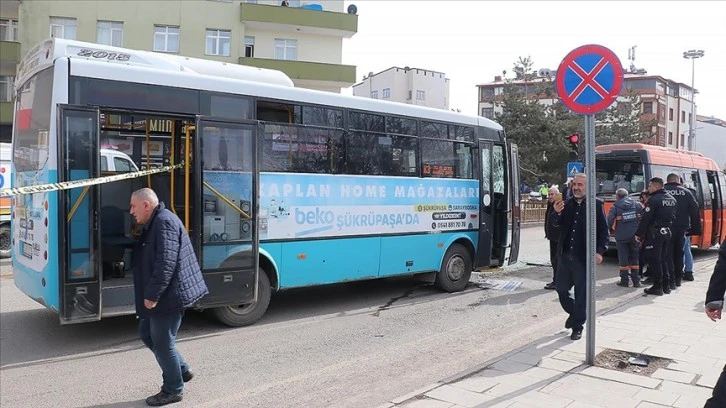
342 0 726 120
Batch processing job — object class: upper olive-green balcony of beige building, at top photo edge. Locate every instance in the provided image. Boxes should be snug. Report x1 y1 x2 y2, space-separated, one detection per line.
240 3 358 38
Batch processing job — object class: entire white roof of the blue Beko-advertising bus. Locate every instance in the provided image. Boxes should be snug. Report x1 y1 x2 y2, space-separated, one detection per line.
16 38 503 131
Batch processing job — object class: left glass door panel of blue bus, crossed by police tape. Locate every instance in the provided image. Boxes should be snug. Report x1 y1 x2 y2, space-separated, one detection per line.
58 106 102 324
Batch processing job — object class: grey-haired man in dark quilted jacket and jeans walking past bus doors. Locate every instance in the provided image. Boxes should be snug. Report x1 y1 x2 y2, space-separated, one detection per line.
130 188 208 406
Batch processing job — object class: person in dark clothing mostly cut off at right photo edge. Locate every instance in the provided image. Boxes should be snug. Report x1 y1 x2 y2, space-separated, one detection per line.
703 240 726 408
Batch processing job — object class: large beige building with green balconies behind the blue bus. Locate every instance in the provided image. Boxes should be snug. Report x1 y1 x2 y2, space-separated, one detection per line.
0 0 358 142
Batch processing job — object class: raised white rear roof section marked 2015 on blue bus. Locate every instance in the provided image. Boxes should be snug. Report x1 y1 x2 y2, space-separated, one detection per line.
16 38 293 89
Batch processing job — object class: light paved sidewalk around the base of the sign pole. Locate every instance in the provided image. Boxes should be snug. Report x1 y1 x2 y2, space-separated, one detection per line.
379 258 726 408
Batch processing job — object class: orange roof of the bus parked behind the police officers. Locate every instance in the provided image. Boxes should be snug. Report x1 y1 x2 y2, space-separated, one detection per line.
595 143 719 171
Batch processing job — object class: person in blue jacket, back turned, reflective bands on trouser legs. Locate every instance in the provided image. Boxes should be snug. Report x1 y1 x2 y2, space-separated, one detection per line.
607 188 643 288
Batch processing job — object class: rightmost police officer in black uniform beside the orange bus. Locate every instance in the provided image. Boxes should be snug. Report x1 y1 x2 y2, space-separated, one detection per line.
664 173 701 289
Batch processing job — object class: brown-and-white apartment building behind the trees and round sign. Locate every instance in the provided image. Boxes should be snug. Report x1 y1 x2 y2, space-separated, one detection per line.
477 69 698 149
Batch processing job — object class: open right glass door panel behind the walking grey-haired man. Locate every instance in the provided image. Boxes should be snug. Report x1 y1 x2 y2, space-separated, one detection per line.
194 119 264 307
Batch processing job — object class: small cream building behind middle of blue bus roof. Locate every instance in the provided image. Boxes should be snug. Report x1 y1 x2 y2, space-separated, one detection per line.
353 67 449 110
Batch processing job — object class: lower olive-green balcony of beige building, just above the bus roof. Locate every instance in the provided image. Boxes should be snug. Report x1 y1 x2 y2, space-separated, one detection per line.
239 57 355 88
